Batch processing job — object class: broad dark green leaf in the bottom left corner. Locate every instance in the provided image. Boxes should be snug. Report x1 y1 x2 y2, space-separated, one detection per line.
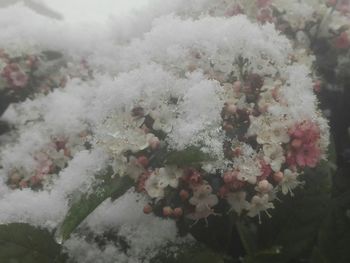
0 223 66 263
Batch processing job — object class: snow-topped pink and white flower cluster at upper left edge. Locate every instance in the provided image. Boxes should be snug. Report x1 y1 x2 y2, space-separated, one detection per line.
0 48 92 105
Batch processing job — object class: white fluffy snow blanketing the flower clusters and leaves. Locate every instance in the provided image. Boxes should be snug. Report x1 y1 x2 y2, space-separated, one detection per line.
0 0 326 263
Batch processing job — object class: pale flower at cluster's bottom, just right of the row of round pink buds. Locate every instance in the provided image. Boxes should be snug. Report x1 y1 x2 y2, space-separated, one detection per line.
189 184 219 212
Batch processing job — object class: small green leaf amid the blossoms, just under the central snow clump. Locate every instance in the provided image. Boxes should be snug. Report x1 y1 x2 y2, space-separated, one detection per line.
165 146 210 166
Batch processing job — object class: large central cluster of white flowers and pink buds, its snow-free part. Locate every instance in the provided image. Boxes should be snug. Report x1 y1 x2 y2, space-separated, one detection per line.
98 68 328 225
